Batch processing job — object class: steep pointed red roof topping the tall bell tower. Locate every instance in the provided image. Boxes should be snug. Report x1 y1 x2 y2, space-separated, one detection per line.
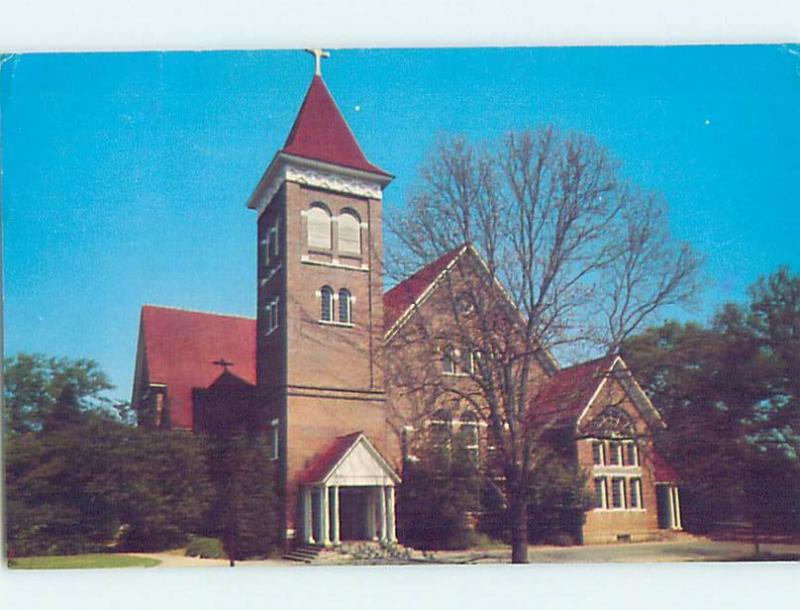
283 76 391 176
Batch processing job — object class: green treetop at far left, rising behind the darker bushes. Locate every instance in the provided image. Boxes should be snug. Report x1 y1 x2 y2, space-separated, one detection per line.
3 352 125 436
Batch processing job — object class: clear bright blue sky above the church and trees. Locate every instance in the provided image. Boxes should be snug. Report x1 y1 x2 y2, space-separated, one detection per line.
0 45 800 398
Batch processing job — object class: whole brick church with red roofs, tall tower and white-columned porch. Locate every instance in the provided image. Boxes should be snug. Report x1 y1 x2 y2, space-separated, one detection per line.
132 56 681 546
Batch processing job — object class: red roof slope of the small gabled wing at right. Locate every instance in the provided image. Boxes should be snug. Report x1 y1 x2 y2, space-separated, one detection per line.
531 355 616 424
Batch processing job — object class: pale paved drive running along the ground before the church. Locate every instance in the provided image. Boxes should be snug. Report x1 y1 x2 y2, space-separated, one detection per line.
130 538 800 568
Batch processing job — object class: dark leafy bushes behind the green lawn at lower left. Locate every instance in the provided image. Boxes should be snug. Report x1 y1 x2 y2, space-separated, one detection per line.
5 416 212 555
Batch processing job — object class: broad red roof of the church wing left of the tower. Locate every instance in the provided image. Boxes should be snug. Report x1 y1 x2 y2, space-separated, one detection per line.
141 305 256 428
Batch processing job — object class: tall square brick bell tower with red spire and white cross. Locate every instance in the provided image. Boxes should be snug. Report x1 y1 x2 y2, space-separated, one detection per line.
247 49 392 532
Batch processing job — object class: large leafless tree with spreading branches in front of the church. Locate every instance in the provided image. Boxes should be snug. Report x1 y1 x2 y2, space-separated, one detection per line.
387 128 698 563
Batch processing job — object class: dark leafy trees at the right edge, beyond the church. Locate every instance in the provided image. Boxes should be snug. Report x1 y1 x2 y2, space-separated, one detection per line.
623 268 800 530
